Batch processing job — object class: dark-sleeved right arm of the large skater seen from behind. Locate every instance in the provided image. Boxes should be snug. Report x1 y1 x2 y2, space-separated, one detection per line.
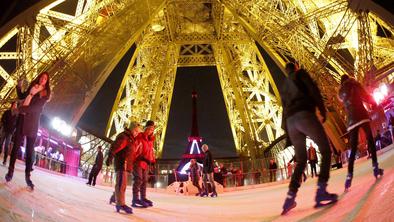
297 71 327 120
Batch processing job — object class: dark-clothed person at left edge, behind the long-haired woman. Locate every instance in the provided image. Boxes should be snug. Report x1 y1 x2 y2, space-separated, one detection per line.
0 102 17 165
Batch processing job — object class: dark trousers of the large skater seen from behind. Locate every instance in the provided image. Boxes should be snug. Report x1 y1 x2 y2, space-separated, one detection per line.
286 111 331 192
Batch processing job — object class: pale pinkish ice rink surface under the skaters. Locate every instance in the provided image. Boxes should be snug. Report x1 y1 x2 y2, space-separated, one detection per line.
0 148 394 222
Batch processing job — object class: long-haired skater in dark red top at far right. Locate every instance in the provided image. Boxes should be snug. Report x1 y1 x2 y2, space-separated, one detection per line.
339 75 383 190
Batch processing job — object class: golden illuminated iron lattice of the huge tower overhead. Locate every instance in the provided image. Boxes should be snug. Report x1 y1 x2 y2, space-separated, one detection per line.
0 0 394 158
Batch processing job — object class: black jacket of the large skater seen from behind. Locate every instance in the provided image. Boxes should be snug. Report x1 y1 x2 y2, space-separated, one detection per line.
281 69 326 125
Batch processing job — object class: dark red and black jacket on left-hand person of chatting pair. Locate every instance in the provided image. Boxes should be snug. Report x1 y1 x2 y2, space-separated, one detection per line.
107 130 136 172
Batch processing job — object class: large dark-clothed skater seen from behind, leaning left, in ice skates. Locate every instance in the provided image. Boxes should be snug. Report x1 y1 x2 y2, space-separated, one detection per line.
281 63 338 215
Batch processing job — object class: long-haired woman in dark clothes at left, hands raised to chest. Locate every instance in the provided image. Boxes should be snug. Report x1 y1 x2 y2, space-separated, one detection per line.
5 72 51 189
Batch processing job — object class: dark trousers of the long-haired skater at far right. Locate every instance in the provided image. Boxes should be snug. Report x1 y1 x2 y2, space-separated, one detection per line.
348 123 378 174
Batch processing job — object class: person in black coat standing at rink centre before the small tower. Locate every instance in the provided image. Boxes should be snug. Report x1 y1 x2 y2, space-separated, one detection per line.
201 144 218 197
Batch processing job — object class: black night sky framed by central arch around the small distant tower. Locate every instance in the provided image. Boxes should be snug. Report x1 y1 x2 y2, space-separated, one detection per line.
163 67 237 158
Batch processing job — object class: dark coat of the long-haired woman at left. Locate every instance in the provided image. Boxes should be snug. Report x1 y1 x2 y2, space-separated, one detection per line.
16 87 49 137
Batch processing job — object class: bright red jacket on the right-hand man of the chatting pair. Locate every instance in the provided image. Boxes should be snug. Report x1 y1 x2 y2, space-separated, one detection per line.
135 133 156 170
